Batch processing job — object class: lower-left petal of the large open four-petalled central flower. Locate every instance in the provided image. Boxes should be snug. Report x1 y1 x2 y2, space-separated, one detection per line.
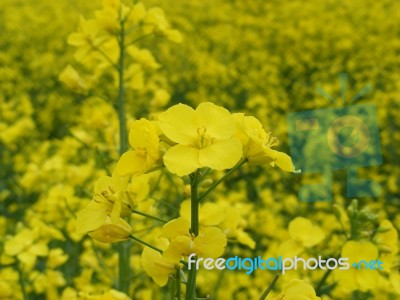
163 145 201 176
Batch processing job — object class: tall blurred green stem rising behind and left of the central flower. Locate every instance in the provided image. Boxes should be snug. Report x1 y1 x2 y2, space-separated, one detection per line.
117 15 132 294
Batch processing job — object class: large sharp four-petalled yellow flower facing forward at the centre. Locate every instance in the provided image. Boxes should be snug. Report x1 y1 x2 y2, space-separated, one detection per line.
159 102 242 176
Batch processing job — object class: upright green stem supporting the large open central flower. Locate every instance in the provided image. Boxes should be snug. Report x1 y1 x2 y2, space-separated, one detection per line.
185 170 199 300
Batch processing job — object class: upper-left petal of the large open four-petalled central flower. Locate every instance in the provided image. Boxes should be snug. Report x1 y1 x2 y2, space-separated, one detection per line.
159 103 199 145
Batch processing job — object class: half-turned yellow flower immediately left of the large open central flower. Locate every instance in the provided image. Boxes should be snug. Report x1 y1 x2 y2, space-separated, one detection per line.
115 118 160 176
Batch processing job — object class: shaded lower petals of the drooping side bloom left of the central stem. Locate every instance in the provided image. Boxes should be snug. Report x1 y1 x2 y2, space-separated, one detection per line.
89 217 132 243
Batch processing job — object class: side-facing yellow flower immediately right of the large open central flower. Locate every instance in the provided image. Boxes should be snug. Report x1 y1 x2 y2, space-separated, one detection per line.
233 113 295 172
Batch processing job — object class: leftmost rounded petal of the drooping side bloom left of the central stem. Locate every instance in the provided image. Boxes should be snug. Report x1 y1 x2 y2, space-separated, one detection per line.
76 201 107 233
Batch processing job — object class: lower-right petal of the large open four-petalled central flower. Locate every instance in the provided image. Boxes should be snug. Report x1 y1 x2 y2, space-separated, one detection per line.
199 138 243 170
